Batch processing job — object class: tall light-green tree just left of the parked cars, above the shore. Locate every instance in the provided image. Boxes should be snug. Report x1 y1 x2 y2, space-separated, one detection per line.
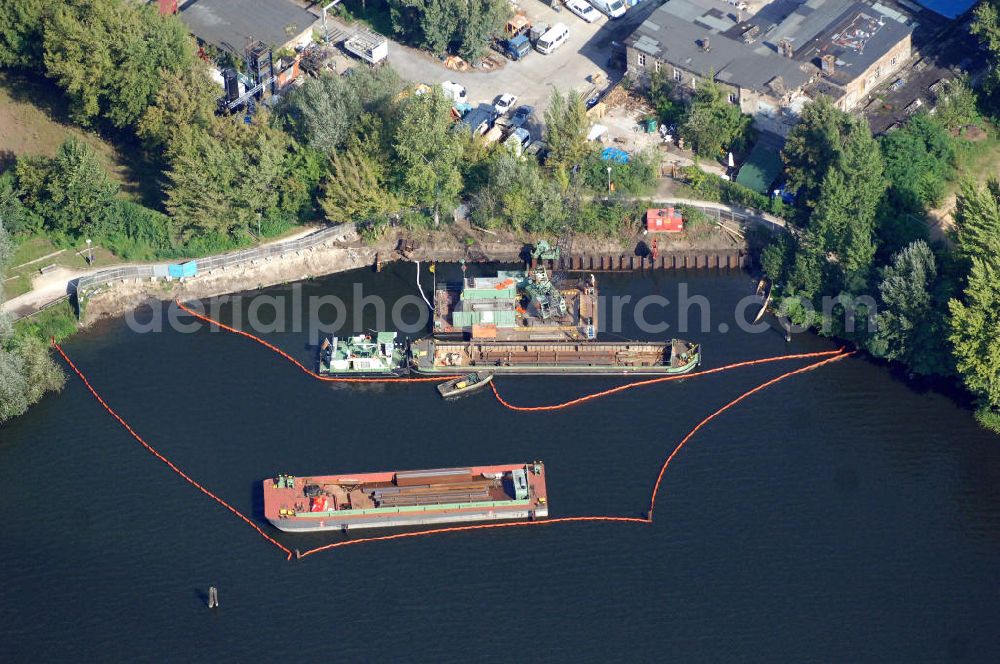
393 87 463 218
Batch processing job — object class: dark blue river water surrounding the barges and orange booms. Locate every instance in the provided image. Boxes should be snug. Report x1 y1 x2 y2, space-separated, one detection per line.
0 266 1000 662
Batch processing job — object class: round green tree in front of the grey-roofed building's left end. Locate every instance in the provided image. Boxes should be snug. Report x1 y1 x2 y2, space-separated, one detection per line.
680 78 752 159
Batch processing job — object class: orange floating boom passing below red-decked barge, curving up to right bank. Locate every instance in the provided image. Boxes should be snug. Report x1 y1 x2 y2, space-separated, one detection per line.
296 349 855 558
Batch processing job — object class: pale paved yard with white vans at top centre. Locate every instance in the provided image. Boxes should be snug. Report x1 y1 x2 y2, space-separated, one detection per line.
356 0 657 117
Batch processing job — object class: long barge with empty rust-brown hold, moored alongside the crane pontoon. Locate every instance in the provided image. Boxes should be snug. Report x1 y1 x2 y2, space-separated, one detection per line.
410 338 701 376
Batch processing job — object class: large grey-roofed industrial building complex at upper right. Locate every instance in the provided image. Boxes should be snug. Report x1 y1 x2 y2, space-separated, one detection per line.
625 0 914 135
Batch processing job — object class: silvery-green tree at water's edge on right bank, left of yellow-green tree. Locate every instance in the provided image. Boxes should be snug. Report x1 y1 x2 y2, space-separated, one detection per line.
868 241 948 375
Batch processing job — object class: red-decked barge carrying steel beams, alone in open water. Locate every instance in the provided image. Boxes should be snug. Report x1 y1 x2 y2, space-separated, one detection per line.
264 461 549 533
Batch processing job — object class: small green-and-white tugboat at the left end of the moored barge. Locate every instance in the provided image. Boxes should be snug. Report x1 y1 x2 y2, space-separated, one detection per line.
319 332 409 377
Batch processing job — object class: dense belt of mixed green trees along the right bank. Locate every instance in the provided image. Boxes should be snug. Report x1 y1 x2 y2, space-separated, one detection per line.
761 80 1000 430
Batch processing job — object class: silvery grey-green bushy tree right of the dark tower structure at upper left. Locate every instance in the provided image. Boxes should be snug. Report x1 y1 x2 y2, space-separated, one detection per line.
280 74 362 152
